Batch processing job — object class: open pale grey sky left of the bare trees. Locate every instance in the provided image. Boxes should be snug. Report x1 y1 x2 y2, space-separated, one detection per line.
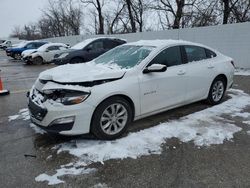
0 0 48 37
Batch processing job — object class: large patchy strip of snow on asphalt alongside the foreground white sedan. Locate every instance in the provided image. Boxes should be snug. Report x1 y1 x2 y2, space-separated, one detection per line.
36 90 250 183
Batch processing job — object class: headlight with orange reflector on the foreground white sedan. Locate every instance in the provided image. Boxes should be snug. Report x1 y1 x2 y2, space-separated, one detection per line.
44 90 90 105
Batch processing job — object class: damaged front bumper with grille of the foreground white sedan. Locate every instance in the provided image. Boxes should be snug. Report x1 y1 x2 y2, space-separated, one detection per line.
27 88 94 135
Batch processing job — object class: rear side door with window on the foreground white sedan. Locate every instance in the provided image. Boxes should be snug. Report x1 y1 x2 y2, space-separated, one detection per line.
183 45 218 101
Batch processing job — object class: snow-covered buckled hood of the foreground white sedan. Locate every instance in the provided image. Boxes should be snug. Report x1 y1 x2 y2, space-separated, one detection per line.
39 61 126 84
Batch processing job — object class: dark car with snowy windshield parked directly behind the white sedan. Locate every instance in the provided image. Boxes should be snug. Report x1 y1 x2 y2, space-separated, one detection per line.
53 38 126 65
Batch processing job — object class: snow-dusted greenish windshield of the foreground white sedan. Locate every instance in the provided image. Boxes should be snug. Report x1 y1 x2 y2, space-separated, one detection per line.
94 45 155 68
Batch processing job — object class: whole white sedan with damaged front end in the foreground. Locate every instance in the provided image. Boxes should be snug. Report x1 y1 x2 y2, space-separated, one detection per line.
28 40 234 139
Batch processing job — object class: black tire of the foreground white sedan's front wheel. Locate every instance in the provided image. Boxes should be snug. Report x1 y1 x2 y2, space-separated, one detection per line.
91 97 132 140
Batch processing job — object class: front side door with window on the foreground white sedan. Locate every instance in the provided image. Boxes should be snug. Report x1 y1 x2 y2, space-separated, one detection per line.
139 46 187 115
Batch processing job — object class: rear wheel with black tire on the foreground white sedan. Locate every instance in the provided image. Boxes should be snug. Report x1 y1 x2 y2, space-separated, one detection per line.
207 76 226 105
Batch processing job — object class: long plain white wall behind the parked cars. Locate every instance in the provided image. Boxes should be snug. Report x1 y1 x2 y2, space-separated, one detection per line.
46 22 250 68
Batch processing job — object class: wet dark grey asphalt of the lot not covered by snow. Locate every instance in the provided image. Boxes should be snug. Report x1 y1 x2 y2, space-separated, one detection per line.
0 51 250 188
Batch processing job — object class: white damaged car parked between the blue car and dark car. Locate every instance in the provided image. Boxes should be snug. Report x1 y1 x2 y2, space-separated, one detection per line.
23 43 69 64
